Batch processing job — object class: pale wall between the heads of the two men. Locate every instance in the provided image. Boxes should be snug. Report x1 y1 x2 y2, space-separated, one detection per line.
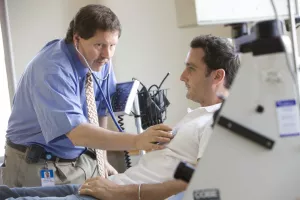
99 0 230 130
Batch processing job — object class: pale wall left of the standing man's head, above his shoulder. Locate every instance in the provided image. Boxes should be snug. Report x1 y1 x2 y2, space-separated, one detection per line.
7 0 97 81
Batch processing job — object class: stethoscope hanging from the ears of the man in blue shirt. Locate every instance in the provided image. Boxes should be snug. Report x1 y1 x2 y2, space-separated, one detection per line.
74 43 123 132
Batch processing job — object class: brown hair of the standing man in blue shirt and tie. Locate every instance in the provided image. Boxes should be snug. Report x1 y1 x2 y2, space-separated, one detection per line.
65 4 122 43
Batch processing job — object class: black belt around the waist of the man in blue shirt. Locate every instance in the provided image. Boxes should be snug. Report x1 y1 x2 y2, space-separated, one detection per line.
6 140 96 162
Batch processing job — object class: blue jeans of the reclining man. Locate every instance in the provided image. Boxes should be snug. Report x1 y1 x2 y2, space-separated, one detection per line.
0 184 95 200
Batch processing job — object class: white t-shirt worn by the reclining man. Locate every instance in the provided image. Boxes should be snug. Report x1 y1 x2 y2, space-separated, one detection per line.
109 104 221 185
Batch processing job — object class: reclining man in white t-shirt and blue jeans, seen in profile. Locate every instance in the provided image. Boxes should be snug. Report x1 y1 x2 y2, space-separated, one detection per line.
0 35 240 200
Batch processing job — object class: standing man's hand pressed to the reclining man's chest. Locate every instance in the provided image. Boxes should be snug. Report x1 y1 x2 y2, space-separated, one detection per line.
135 124 173 151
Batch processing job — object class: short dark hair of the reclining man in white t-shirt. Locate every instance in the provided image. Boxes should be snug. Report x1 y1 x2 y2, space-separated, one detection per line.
190 35 240 89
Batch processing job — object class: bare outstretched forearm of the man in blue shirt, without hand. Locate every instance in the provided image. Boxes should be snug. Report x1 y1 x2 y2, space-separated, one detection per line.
67 124 136 151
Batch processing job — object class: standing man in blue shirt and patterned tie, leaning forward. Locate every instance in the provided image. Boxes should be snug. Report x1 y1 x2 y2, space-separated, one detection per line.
2 5 172 187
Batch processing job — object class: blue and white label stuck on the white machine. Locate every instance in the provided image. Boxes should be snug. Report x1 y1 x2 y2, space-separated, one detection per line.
276 99 300 137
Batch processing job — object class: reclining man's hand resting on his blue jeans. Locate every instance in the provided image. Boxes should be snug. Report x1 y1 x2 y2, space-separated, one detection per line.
78 177 119 200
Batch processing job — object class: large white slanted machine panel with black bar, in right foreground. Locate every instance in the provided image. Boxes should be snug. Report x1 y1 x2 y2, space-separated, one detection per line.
184 39 300 200
